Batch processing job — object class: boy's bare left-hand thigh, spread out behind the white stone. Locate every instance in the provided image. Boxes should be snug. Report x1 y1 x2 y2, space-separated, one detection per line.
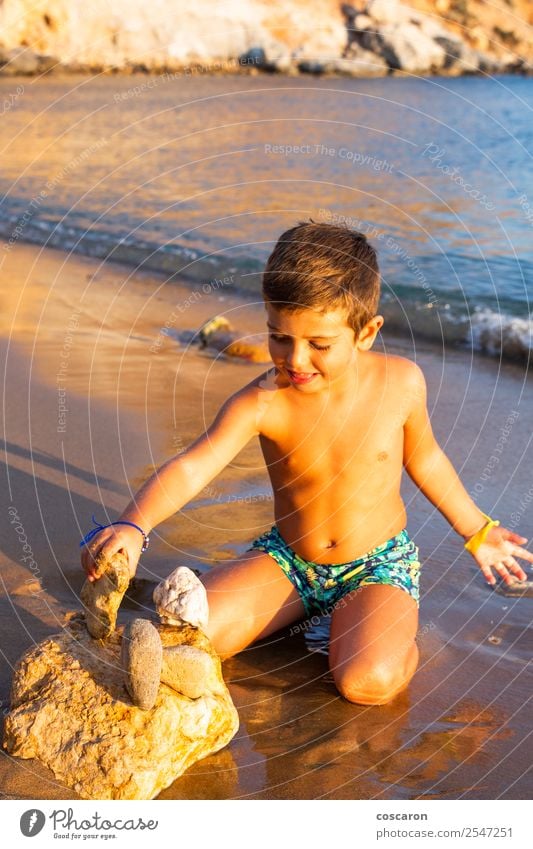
201 550 305 659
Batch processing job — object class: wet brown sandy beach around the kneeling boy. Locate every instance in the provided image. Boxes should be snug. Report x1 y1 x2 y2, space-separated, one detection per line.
0 244 533 799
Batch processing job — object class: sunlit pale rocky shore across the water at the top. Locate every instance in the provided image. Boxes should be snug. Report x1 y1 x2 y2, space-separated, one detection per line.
0 0 533 77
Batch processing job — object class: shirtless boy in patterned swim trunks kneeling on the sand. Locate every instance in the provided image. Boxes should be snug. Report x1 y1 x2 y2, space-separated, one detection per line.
82 223 533 705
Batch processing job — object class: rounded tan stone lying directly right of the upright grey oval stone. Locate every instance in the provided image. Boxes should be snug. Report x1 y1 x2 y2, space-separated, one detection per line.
161 646 221 699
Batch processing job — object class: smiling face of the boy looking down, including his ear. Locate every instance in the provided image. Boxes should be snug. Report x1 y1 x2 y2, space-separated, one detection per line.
266 301 383 394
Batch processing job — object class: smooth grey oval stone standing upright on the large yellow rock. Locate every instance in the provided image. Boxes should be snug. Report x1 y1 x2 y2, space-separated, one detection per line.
120 619 163 710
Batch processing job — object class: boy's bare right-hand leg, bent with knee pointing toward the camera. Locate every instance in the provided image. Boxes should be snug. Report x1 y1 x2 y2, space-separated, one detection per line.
329 584 418 705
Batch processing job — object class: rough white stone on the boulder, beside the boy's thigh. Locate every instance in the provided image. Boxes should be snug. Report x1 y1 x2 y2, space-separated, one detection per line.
154 566 209 631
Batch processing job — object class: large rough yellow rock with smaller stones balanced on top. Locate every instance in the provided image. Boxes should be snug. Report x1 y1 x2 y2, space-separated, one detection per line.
4 617 239 799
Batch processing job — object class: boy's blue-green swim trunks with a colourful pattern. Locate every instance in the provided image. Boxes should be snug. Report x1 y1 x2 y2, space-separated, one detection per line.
251 526 420 616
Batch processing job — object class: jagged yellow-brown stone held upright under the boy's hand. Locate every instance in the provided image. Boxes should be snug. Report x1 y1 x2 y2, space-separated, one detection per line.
80 552 130 640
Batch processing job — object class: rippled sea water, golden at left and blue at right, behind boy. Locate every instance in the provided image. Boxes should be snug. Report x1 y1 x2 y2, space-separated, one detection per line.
0 74 533 362
